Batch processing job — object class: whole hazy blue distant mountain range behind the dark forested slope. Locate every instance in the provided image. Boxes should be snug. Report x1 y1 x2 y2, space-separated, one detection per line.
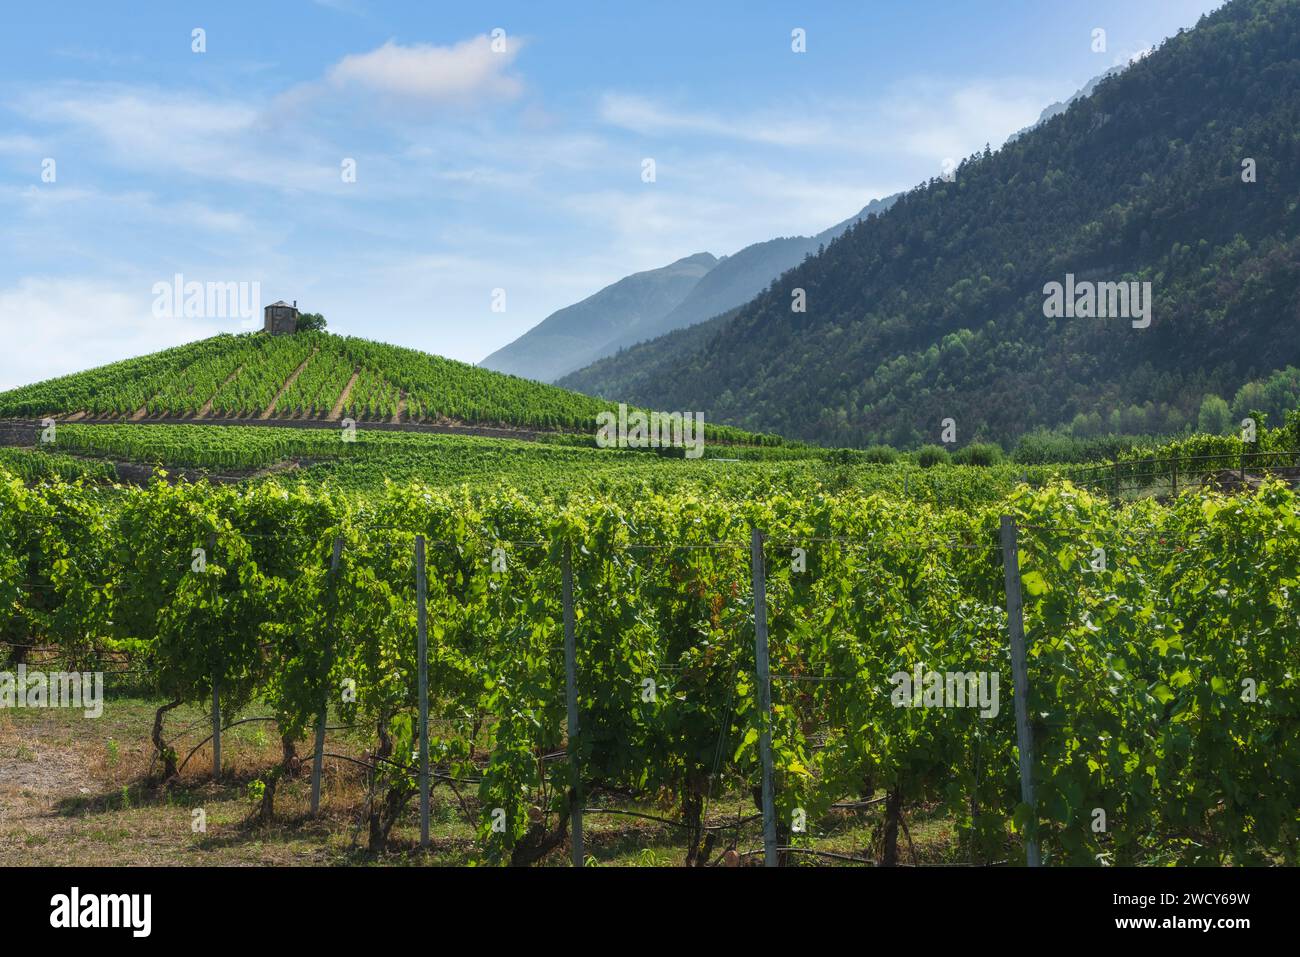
480 195 898 382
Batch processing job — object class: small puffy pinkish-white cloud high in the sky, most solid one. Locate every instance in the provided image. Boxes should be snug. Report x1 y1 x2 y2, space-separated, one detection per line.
328 35 523 104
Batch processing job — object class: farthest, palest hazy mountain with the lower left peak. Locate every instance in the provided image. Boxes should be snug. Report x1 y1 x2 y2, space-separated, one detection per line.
480 252 718 382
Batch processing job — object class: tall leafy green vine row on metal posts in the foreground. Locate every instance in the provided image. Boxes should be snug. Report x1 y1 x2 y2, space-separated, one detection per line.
0 480 1300 865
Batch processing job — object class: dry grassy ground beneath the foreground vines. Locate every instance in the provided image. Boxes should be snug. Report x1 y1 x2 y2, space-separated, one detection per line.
0 697 977 866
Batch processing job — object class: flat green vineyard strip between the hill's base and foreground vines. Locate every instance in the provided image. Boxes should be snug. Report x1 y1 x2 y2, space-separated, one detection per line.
12 423 1057 506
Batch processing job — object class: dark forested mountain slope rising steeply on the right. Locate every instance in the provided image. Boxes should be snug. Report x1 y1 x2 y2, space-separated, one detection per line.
562 0 1300 445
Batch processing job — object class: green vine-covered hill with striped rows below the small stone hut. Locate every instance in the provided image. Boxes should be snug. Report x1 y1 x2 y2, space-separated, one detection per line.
0 333 642 432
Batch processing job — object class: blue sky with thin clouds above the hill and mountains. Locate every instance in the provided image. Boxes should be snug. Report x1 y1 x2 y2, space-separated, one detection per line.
0 0 1219 387
